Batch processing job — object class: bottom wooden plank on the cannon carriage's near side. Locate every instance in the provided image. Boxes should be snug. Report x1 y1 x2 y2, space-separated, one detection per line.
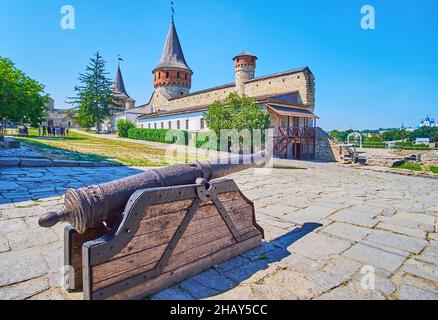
102 236 262 300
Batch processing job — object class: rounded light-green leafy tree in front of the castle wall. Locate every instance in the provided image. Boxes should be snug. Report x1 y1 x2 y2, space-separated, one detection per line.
204 93 270 135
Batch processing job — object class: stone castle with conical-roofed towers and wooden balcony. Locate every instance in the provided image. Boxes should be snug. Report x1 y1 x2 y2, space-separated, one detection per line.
48 17 336 160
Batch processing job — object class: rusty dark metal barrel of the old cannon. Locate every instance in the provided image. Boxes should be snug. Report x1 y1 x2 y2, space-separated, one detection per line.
38 152 265 234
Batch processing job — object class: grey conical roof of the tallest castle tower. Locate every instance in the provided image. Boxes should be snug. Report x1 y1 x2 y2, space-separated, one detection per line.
156 19 191 71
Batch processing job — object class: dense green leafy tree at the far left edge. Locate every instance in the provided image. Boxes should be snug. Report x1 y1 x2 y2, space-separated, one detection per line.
0 57 49 127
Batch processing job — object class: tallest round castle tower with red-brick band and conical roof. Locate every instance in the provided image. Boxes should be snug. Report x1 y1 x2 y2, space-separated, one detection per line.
152 18 193 99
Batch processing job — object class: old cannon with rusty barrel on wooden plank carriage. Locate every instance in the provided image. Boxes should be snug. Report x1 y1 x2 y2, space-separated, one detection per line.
39 153 264 300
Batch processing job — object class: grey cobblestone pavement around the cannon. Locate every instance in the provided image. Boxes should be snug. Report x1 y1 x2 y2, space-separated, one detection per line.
0 163 438 300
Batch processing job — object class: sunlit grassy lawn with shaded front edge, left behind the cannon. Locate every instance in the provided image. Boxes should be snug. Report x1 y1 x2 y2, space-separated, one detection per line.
10 129 202 167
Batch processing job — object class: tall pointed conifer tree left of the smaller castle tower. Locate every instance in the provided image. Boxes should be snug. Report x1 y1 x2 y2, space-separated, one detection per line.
69 52 117 131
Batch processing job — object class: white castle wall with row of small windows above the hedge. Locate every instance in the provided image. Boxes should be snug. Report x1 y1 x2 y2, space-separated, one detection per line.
137 112 208 131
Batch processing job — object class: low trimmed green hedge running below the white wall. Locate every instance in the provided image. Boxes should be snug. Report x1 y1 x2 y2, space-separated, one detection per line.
128 128 189 145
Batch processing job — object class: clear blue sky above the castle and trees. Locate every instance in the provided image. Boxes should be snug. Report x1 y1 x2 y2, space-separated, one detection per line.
0 0 438 129
